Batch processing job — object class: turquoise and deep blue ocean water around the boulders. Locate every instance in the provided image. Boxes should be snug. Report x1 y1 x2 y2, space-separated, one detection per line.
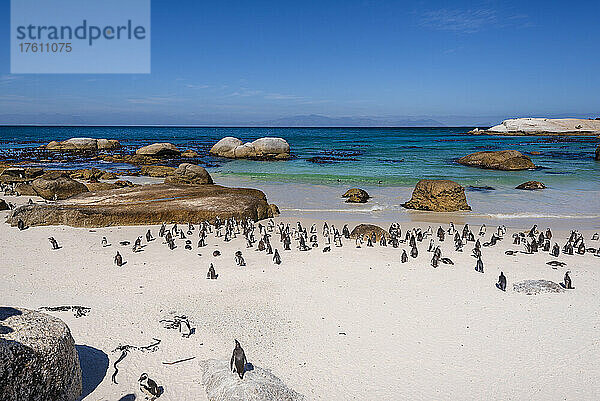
0 126 600 227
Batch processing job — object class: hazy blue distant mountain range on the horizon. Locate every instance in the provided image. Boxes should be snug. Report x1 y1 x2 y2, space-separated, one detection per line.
256 114 445 127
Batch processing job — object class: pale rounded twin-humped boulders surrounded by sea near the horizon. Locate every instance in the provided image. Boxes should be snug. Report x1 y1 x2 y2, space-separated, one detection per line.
210 137 290 160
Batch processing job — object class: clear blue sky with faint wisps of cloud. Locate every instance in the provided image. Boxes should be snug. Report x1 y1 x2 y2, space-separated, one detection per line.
0 0 600 124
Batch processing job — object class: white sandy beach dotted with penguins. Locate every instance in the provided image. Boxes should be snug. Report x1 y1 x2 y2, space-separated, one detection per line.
0 192 600 401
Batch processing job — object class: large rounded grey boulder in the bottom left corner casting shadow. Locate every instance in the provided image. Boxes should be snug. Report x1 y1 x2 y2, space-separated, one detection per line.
0 307 82 401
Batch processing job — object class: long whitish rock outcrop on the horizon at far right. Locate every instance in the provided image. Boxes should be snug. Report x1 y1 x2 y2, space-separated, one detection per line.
480 118 600 135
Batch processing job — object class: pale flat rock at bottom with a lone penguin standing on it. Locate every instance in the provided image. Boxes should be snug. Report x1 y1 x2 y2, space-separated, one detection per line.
200 359 305 401
